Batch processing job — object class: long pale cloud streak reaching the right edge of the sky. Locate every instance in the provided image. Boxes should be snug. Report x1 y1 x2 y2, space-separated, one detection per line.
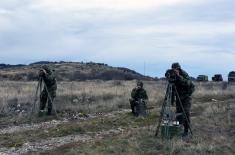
128 21 235 38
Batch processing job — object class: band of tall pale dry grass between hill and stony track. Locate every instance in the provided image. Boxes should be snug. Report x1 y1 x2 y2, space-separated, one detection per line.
0 81 235 115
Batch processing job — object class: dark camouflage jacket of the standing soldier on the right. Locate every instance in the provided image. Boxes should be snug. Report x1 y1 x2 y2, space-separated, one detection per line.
175 69 195 96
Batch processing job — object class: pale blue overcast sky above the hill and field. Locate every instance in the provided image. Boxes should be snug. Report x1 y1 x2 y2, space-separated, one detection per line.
0 0 235 78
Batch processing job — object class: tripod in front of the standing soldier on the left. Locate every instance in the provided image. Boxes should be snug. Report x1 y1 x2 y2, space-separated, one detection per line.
30 77 58 119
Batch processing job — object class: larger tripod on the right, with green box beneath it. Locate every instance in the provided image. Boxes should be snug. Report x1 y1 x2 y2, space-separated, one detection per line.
155 82 193 139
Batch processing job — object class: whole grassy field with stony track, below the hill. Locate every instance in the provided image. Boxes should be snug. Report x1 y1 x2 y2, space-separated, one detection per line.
0 81 235 155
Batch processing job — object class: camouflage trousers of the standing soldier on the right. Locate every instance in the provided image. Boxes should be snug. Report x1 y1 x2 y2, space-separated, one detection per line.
176 96 192 133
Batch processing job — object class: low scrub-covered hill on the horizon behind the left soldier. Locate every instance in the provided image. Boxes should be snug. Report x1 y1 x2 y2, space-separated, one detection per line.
0 61 153 81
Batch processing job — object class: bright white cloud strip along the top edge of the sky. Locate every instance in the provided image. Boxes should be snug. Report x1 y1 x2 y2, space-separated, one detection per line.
32 0 185 11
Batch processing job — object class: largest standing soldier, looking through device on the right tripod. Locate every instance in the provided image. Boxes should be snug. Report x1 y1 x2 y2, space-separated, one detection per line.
171 63 195 137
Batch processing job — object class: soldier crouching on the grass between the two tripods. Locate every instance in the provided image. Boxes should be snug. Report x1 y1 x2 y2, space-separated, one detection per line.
130 81 148 116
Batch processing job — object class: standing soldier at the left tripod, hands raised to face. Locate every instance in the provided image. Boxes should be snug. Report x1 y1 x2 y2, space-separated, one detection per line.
39 65 57 116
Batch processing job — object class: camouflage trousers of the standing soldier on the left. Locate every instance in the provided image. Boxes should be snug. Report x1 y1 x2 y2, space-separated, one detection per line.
40 88 56 115
